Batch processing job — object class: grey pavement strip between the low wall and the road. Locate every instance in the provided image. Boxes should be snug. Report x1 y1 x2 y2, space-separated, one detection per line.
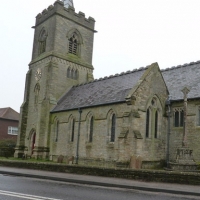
0 167 200 197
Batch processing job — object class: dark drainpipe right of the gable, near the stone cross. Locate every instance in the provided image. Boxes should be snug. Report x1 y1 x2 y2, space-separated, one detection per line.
166 96 171 169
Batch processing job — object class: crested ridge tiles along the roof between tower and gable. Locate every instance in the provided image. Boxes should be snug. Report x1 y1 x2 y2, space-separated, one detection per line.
73 65 150 87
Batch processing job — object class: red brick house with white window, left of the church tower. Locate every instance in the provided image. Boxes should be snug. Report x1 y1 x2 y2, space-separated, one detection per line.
0 107 19 140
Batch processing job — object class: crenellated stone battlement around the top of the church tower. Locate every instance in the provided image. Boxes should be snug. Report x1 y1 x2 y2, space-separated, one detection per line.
35 0 95 30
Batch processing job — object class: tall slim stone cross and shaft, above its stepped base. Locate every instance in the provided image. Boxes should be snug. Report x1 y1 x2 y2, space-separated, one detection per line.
181 87 190 147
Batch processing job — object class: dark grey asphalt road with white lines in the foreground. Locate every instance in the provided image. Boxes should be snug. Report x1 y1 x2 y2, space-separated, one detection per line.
0 174 200 200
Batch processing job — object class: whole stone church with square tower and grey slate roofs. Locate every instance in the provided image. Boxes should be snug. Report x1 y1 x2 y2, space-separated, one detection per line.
15 0 200 168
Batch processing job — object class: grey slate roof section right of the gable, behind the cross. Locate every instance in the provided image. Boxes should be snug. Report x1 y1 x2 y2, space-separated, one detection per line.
162 61 200 100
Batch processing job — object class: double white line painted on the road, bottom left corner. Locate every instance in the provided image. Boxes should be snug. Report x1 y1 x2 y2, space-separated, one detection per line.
0 190 61 200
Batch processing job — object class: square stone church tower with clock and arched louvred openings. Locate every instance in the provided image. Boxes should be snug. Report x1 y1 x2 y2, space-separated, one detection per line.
15 0 95 158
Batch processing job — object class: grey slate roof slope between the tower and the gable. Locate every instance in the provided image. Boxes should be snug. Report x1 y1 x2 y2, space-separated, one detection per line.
52 68 145 112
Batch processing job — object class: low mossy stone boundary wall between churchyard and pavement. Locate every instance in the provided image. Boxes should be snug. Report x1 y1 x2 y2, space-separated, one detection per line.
0 160 200 185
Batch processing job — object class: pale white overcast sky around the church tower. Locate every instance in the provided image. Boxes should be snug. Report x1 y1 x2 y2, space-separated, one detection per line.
0 0 200 112
